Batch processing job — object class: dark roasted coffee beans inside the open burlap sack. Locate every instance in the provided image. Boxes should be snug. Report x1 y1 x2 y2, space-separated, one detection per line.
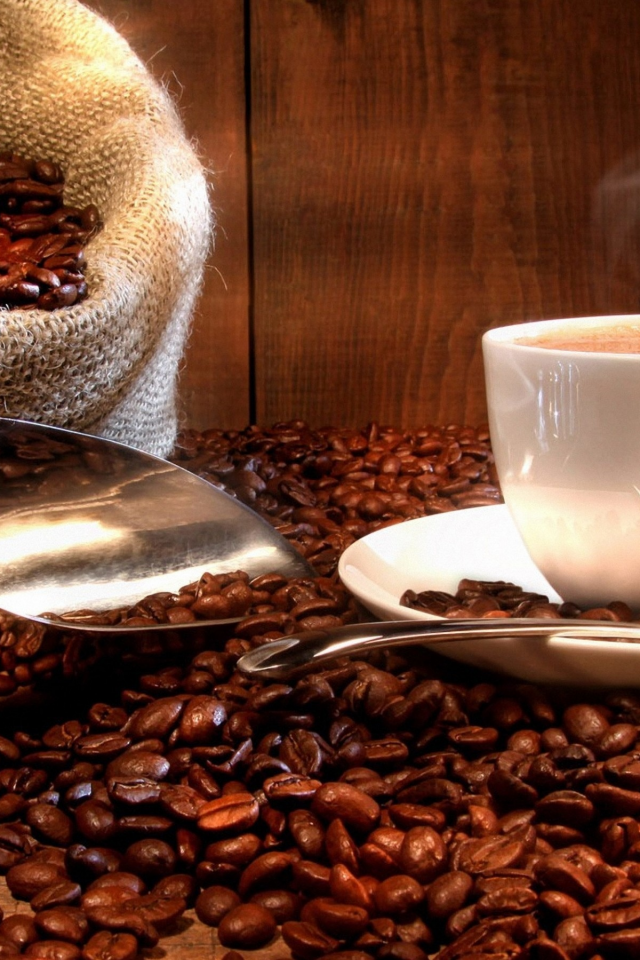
0 153 100 310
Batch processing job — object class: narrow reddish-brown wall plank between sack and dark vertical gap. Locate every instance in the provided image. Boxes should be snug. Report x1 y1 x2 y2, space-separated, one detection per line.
80 0 250 428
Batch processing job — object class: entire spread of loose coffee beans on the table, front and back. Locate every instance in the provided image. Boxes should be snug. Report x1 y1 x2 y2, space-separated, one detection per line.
0 423 640 960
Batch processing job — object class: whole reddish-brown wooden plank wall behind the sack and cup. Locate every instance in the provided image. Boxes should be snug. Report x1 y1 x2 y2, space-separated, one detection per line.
82 0 640 427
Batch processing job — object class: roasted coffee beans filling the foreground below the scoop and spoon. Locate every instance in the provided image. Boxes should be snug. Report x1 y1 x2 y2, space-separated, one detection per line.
0 624 640 960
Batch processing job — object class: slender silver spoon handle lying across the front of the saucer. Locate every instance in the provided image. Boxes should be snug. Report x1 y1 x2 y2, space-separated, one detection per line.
238 617 640 680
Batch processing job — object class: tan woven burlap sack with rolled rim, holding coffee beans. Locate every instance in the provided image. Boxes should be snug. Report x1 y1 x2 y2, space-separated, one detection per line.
0 0 211 456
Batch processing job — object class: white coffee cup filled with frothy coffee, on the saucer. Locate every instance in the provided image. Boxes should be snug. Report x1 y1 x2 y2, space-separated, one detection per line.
482 315 640 611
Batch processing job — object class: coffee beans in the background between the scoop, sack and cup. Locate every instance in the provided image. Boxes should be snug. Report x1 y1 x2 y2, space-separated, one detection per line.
173 421 502 574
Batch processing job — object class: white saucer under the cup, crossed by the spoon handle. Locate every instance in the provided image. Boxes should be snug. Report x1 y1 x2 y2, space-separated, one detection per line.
338 504 640 687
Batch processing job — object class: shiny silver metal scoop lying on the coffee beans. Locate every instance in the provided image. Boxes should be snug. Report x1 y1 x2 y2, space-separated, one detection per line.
0 418 315 632
